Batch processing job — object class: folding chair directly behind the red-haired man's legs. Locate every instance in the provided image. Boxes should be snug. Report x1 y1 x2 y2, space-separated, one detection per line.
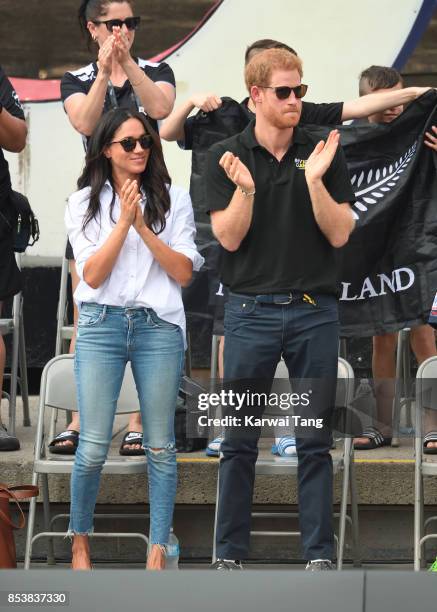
212 358 361 570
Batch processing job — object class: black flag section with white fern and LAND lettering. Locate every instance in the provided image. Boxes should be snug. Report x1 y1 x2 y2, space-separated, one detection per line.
339 90 437 337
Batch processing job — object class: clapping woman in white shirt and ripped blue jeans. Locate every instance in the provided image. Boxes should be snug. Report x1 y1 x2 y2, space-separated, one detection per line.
65 109 203 569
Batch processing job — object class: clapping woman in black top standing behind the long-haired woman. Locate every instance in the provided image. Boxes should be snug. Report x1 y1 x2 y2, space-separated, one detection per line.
53 0 176 455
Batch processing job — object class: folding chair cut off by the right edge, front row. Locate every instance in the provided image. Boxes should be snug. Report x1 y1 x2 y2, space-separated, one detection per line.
414 357 437 572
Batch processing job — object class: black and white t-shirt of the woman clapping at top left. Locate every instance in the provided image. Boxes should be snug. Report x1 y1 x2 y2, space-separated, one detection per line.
61 58 176 131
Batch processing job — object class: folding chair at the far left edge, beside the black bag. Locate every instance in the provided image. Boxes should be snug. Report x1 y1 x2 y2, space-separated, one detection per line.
0 286 30 436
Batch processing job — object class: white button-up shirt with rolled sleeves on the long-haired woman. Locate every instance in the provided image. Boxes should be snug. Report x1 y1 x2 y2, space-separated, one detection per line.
65 181 204 344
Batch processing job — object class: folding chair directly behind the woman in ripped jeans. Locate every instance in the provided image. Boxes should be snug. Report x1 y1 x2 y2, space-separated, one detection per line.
24 355 148 569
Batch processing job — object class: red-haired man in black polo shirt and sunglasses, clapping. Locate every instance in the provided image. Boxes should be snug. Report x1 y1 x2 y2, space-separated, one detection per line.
206 49 354 570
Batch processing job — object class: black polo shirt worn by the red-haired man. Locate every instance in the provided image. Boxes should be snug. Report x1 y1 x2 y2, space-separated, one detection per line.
206 122 355 295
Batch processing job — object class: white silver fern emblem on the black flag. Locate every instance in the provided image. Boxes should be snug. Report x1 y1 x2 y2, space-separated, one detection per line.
351 140 418 219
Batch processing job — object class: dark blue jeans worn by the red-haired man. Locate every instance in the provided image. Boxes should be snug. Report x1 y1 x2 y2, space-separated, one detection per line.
217 294 339 561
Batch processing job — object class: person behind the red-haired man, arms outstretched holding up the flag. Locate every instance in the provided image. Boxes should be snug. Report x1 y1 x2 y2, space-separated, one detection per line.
160 39 428 457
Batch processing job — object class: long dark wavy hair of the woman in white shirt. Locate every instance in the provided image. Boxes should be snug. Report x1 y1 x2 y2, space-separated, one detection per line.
77 108 171 234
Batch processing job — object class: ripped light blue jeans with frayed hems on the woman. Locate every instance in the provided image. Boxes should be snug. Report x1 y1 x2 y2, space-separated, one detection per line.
69 303 184 544
